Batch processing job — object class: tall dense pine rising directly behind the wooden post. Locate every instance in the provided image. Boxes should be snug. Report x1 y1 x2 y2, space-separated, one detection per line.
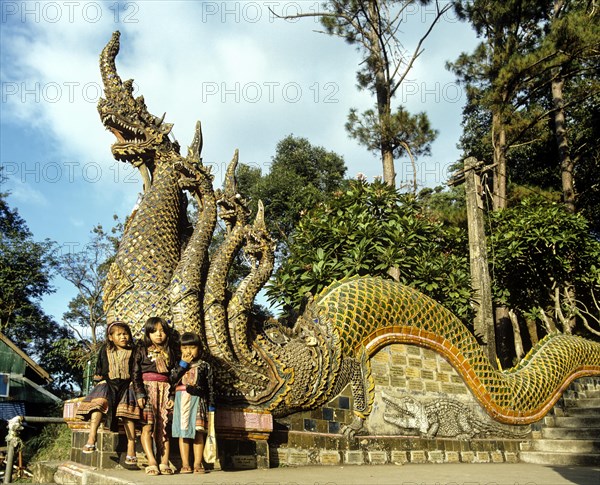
448 0 544 210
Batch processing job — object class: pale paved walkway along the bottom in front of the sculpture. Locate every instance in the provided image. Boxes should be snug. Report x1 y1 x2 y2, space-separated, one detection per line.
65 463 600 485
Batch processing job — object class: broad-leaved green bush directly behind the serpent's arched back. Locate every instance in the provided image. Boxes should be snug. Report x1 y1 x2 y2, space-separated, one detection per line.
267 181 471 322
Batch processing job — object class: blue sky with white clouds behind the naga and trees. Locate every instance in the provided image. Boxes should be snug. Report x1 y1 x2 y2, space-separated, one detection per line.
0 0 476 332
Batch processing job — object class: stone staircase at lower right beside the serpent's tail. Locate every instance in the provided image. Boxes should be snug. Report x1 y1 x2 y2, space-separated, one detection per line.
519 377 600 466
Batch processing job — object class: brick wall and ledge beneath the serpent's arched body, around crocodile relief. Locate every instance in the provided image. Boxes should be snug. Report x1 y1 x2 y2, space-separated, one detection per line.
269 344 529 466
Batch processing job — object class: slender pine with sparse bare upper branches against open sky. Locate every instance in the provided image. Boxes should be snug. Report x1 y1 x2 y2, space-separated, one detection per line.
274 0 451 186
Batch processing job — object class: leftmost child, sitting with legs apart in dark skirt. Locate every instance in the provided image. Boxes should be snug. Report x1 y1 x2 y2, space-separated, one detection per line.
76 322 141 465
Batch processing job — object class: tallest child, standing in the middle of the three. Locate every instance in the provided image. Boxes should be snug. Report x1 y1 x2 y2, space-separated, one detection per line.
133 317 176 475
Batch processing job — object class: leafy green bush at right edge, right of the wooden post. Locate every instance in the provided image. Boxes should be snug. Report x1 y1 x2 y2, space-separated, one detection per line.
489 197 600 330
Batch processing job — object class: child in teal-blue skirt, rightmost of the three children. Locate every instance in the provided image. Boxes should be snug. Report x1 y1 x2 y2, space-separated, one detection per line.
171 332 215 473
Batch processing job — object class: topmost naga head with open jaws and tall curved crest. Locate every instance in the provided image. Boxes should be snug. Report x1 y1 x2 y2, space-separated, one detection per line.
98 31 173 165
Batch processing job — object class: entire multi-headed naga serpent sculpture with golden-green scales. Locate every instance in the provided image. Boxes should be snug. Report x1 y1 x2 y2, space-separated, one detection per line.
98 32 600 436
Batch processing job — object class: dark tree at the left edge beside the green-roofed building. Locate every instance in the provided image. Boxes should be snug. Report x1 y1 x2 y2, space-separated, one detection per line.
0 172 79 396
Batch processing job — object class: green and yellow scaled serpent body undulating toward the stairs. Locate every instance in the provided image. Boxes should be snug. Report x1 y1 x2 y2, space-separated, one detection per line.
317 278 600 424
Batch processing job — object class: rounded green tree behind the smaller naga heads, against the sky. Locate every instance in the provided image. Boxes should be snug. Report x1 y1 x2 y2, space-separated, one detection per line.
237 135 346 255
